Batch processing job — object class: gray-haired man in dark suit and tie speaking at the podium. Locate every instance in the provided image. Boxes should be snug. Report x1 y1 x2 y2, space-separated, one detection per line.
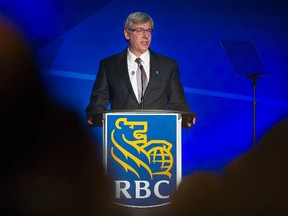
86 12 194 128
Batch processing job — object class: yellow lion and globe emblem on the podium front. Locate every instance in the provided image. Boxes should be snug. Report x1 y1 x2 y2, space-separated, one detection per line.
110 118 173 180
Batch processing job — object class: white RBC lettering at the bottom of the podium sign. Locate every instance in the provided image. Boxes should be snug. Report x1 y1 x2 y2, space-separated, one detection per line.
115 180 170 199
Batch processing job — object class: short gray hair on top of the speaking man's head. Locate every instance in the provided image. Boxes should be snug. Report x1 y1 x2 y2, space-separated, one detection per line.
124 12 154 29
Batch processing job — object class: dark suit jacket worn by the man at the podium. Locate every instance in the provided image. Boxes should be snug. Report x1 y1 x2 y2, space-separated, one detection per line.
86 50 190 117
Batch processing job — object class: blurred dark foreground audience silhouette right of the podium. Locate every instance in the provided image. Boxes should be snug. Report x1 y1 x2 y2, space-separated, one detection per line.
171 119 288 216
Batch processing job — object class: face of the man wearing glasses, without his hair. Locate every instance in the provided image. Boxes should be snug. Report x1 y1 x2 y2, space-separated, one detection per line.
124 22 152 57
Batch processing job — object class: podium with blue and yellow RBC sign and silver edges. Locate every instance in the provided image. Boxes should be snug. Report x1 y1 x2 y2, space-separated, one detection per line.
99 110 195 208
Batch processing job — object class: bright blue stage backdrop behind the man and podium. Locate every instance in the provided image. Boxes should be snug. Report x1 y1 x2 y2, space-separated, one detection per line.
0 0 288 175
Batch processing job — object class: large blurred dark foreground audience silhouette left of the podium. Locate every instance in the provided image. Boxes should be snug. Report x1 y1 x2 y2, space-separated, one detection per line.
0 16 120 216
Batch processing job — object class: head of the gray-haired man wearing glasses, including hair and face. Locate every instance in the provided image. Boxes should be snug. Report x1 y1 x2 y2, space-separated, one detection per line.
124 12 154 57
